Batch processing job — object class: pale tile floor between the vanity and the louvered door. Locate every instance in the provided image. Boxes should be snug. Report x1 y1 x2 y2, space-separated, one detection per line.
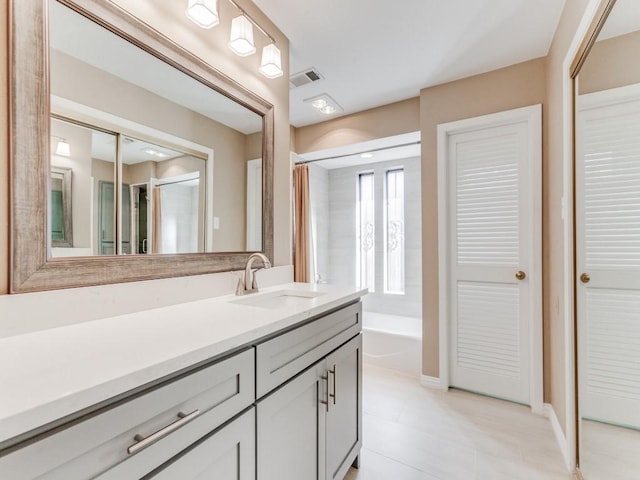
345 364 573 480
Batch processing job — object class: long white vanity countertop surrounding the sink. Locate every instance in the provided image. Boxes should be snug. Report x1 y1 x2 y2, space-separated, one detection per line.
0 283 366 442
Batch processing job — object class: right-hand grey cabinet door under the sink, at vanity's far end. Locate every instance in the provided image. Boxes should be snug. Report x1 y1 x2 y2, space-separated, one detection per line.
325 335 362 480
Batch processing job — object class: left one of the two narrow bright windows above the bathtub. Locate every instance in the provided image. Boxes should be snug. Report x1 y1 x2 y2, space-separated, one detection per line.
356 173 376 292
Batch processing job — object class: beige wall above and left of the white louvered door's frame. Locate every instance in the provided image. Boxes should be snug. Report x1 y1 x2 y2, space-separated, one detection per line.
420 59 545 377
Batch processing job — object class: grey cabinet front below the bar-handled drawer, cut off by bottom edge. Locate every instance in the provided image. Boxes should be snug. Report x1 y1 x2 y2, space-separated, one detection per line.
144 408 256 480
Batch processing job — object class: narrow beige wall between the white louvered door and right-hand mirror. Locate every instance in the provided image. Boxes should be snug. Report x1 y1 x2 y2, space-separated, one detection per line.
542 0 588 428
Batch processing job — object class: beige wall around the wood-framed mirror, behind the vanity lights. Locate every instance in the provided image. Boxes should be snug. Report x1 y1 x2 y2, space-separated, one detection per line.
0 0 291 294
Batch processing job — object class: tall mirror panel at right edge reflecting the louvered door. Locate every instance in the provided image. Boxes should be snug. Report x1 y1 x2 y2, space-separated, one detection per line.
576 0 640 480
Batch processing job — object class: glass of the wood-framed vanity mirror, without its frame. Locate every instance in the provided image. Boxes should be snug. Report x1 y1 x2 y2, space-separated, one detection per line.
48 0 263 257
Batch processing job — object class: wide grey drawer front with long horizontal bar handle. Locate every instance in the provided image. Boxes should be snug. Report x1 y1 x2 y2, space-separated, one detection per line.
0 349 255 480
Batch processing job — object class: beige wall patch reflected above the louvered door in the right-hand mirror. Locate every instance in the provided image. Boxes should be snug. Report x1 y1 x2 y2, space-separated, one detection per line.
578 31 640 94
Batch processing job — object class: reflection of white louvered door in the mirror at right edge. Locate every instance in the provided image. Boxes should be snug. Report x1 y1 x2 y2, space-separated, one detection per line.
576 89 640 428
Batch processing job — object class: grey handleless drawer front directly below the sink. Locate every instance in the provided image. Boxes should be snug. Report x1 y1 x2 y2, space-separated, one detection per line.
256 302 362 398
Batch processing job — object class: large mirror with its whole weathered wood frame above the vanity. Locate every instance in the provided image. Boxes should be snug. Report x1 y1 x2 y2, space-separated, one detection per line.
11 0 274 292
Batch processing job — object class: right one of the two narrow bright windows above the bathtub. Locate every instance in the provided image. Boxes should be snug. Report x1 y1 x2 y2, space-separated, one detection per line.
384 169 404 294
